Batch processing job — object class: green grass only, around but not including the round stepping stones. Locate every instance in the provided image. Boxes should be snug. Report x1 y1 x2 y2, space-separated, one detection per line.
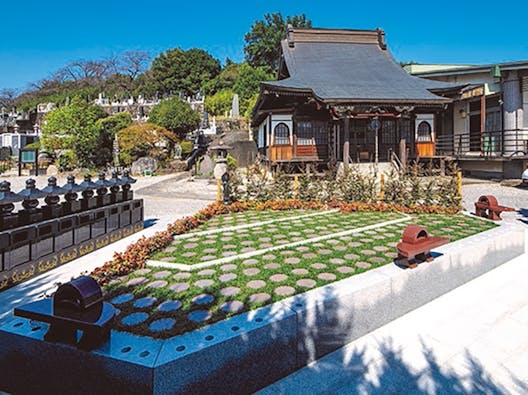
105 212 496 338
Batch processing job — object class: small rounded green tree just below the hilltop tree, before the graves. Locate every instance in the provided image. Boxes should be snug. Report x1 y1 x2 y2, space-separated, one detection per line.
149 97 200 138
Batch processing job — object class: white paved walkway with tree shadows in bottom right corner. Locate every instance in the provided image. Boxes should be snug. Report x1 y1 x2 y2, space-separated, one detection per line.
259 254 528 394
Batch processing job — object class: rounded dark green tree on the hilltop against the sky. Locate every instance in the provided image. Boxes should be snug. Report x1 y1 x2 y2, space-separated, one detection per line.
151 48 220 95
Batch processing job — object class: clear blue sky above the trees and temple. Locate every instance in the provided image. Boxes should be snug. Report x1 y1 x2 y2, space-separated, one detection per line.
0 0 528 89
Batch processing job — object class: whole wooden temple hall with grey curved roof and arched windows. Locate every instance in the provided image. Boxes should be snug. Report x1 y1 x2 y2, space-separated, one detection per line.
252 27 453 171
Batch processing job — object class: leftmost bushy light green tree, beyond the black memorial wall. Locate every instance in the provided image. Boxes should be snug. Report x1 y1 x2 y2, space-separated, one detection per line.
41 96 106 166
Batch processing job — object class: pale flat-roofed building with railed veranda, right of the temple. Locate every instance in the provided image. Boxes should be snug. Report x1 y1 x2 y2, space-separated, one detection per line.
406 61 528 178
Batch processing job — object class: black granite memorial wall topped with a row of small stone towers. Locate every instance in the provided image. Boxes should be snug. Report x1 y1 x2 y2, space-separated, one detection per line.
0 174 143 291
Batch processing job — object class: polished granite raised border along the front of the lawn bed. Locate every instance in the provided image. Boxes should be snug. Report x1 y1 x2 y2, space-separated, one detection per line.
0 225 525 394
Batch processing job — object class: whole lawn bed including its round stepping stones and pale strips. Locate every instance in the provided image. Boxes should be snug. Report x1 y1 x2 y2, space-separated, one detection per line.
105 210 495 338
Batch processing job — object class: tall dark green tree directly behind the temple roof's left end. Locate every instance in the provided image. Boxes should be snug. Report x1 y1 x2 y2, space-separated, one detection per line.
244 12 312 71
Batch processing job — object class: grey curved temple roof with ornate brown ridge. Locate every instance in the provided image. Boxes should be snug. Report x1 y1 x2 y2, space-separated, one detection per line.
262 29 454 104
